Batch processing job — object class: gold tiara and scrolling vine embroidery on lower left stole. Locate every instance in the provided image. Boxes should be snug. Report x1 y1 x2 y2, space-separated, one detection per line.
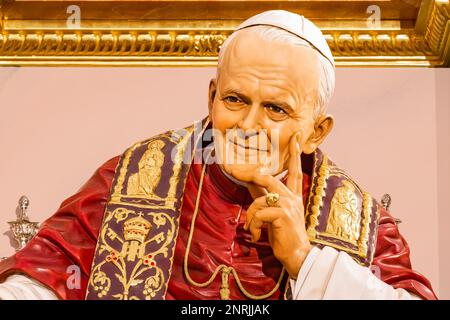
89 208 176 300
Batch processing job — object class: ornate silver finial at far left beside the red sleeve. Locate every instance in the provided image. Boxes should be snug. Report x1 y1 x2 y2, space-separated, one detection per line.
8 196 39 251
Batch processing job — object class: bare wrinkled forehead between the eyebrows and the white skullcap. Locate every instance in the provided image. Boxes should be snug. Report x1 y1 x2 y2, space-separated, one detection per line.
218 28 321 91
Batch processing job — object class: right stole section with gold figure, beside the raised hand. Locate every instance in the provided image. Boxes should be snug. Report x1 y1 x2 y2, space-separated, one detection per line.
306 152 379 265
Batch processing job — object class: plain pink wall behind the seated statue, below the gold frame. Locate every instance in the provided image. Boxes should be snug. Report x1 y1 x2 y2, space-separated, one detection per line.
0 68 450 298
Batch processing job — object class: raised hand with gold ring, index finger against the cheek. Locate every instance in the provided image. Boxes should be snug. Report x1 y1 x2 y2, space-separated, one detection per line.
245 133 311 279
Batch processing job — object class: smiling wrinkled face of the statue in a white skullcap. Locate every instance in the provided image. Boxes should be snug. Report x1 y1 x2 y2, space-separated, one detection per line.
209 28 331 180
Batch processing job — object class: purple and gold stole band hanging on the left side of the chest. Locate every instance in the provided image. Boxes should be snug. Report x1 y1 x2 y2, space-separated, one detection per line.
86 118 209 300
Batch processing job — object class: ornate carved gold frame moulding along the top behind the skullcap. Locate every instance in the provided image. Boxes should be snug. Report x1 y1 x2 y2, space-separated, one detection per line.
0 0 450 67
